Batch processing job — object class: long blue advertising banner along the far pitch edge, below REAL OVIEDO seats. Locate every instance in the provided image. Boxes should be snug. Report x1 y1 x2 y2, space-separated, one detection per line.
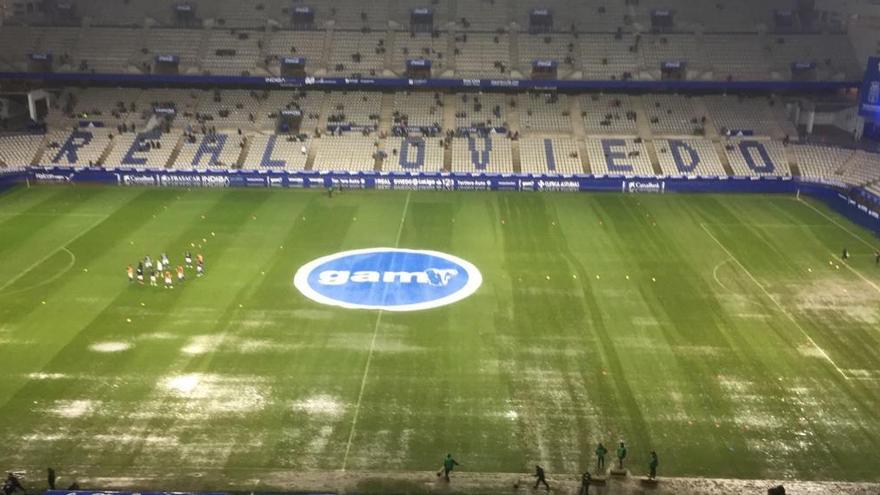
10 167 880 235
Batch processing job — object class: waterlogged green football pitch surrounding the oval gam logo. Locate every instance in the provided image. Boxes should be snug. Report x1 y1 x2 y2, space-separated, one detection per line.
0 186 880 489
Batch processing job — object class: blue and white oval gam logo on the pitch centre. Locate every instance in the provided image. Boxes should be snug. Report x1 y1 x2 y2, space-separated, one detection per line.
293 248 483 311
